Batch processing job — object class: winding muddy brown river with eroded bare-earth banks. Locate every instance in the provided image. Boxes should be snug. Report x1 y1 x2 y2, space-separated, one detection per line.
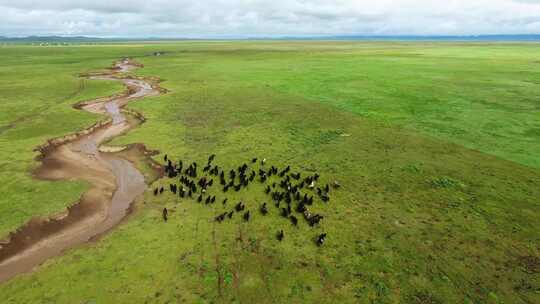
0 60 161 282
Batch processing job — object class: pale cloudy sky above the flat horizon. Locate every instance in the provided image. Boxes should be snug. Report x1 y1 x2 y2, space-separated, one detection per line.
0 0 540 38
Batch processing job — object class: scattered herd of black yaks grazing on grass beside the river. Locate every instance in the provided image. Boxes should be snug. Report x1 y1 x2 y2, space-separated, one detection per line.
154 154 340 246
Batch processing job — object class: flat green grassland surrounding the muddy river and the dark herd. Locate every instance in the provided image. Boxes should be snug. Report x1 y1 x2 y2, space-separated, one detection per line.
0 42 540 303
